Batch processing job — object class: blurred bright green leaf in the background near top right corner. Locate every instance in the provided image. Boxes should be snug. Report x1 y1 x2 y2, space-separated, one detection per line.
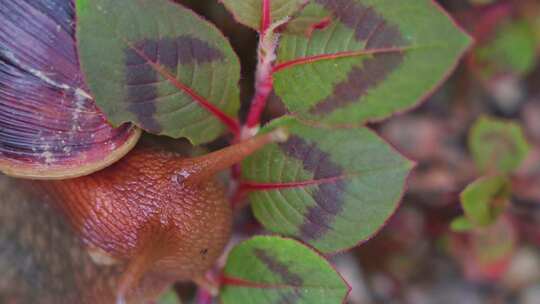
475 21 536 78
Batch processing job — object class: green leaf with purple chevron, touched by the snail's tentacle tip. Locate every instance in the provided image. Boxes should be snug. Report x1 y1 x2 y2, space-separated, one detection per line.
242 117 413 253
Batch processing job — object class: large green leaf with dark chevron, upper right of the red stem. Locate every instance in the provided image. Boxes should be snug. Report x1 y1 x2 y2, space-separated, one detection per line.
274 0 471 124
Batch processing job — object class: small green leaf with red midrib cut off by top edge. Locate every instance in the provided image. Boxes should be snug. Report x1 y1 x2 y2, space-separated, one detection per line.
220 0 307 31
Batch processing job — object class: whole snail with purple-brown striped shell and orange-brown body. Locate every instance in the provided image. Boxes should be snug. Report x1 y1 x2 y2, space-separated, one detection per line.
0 0 286 300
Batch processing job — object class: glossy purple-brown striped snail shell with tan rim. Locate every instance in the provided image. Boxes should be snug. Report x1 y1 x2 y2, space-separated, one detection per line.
0 0 141 179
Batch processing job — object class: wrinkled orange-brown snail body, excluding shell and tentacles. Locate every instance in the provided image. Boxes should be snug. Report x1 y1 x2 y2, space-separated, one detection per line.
40 149 232 280
